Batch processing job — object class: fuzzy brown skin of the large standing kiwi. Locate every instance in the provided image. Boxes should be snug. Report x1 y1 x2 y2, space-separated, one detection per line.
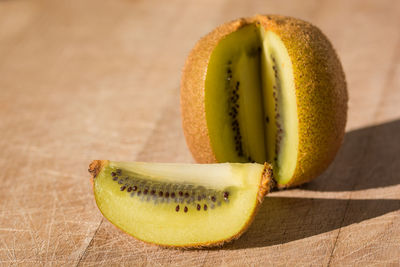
181 15 348 188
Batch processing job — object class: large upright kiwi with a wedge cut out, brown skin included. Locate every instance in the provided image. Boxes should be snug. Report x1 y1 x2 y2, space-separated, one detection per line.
181 15 348 188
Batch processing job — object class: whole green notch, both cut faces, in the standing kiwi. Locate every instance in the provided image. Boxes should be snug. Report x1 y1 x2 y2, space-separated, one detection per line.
205 23 298 183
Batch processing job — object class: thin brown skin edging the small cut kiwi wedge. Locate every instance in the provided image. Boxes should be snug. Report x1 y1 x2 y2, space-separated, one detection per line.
88 160 274 249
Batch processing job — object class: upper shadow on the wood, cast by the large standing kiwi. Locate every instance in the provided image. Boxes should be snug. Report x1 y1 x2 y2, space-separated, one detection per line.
301 120 400 191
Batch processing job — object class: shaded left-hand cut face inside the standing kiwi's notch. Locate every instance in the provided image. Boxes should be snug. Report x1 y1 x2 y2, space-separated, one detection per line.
205 25 266 163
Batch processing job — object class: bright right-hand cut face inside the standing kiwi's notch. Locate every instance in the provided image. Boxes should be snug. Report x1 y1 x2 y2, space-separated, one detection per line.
260 27 299 184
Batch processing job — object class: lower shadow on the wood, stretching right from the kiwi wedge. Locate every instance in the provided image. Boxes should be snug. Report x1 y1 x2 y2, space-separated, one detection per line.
222 197 400 249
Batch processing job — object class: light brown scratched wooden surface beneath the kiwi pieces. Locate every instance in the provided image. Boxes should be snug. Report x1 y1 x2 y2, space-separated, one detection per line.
0 0 400 266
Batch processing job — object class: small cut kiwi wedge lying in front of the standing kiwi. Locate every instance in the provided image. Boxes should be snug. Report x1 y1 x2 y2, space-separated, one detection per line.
89 160 272 247
